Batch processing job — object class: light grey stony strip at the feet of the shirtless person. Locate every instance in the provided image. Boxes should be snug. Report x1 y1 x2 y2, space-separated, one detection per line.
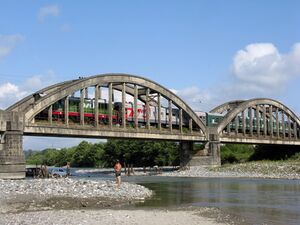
0 178 152 200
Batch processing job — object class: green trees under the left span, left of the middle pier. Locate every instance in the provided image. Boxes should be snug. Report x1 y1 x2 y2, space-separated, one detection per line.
25 140 180 167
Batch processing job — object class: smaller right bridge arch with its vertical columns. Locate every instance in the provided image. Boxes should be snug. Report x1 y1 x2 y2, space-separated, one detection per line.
214 98 300 140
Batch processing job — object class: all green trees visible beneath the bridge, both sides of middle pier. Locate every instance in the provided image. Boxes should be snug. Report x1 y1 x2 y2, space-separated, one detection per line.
25 140 300 167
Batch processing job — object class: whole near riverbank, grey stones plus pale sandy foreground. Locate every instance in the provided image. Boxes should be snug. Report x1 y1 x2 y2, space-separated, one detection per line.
0 178 233 225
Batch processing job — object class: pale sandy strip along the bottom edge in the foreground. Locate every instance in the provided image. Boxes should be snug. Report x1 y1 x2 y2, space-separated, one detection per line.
0 209 227 225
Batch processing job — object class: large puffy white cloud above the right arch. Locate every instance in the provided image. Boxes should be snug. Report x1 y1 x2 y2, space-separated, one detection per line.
232 43 300 94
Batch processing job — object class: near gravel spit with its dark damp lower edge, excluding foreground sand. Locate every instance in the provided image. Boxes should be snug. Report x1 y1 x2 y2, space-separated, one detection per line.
0 178 152 214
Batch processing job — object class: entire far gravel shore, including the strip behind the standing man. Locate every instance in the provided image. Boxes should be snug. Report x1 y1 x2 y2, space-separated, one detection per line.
76 160 300 179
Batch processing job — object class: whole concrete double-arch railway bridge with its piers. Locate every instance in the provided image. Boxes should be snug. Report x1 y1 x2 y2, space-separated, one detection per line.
0 74 300 178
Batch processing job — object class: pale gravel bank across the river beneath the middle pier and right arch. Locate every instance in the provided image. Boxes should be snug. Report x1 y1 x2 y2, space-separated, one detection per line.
160 161 300 179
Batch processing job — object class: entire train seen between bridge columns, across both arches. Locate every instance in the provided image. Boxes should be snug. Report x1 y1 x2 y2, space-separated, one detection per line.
35 97 294 134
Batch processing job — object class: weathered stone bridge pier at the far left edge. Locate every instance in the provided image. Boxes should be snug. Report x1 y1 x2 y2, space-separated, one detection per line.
0 113 25 179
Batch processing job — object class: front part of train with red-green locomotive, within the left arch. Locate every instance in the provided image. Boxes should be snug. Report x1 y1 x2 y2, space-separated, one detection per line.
35 97 184 126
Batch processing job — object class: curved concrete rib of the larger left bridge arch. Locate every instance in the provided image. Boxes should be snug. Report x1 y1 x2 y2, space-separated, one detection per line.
7 74 206 136
